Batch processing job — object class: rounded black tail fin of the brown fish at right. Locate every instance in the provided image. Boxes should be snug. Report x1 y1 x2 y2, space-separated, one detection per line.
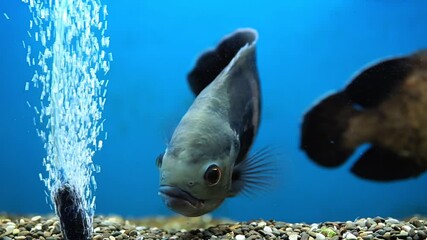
300 92 358 167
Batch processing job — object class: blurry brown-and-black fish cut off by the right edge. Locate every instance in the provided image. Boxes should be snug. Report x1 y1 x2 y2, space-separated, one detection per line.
301 51 427 181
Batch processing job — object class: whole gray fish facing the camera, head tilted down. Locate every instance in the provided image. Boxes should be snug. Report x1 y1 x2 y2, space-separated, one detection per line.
157 29 269 217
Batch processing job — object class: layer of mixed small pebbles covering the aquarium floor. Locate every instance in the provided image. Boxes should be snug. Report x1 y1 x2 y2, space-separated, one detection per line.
0 216 427 240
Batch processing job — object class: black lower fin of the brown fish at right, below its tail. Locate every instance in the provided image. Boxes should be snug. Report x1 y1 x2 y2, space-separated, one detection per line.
351 146 426 181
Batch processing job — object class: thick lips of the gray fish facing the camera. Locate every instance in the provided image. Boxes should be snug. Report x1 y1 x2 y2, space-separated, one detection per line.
159 185 204 208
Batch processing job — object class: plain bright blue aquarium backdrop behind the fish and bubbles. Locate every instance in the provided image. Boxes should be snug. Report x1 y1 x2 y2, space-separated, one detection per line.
0 0 427 222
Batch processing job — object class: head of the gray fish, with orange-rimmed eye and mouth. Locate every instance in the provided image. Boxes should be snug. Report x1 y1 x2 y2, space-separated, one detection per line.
157 133 237 217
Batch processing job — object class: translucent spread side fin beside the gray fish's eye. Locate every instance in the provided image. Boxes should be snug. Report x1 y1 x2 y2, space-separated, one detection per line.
228 147 277 197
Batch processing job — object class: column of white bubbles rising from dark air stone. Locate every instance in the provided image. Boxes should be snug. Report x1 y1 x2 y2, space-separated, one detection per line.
22 0 112 239
